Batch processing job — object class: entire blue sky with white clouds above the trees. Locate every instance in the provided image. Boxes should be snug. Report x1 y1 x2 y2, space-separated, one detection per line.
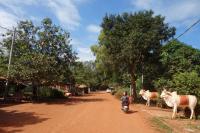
0 0 200 61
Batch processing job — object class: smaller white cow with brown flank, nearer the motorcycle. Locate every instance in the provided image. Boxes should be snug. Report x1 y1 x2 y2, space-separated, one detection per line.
139 89 159 106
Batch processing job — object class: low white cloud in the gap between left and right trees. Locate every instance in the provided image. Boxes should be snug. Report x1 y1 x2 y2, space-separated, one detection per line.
77 47 95 61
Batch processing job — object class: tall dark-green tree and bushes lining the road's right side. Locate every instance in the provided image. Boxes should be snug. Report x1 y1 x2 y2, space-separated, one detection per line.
91 10 200 106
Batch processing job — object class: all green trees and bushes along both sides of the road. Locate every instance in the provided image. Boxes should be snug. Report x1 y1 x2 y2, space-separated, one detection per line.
0 10 200 110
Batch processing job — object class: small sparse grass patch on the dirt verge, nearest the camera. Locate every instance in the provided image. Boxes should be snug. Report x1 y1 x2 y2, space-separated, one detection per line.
151 117 173 133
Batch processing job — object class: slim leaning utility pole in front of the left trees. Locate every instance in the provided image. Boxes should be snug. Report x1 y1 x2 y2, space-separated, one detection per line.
4 28 16 100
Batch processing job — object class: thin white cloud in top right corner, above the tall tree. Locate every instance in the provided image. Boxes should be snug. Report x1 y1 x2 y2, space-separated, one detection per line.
132 0 200 26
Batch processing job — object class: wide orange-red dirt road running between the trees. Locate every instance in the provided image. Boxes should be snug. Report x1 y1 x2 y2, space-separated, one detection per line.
0 92 156 133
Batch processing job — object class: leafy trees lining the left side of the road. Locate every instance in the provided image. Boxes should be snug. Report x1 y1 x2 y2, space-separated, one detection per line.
0 18 100 100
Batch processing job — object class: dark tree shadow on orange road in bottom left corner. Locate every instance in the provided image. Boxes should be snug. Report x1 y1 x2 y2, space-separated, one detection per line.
0 110 48 133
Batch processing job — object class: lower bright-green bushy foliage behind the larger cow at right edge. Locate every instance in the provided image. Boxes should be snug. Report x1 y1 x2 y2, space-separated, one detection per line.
154 40 200 97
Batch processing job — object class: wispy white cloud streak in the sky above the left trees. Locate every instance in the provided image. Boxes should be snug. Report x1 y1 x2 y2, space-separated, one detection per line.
0 0 82 29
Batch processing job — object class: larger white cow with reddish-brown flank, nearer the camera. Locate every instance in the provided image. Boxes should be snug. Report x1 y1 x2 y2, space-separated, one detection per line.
160 89 197 119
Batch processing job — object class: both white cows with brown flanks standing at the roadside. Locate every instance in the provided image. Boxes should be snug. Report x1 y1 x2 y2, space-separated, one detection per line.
139 89 197 119
